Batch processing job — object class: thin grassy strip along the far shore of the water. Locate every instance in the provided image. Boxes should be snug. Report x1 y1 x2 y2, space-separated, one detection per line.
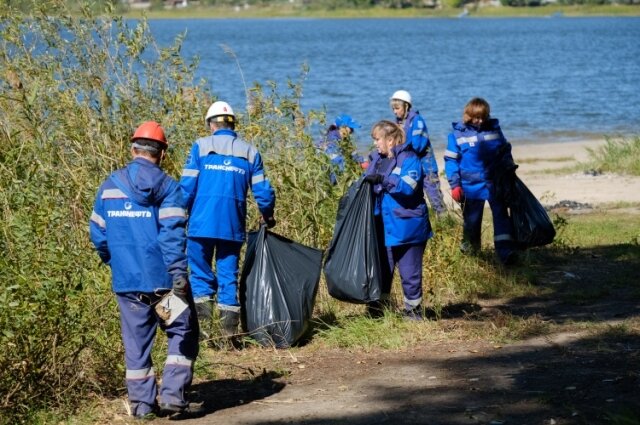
125 5 640 19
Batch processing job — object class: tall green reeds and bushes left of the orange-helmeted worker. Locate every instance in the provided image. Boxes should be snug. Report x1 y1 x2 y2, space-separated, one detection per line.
0 0 206 422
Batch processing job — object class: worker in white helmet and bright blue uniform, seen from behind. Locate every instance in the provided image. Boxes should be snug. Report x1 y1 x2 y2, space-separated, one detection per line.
180 101 276 338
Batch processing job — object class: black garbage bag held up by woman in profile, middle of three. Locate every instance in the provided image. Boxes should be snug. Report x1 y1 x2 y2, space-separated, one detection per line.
324 179 382 304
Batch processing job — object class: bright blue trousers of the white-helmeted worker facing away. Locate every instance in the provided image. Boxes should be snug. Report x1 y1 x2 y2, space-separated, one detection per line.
187 238 242 308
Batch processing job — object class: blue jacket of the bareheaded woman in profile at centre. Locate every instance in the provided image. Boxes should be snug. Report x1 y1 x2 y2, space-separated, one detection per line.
365 143 433 246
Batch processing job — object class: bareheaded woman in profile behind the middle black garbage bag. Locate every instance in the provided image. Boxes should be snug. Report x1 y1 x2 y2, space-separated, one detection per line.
364 120 432 320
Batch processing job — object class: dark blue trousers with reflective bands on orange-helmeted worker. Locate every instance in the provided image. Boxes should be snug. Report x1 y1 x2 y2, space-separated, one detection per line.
116 292 199 416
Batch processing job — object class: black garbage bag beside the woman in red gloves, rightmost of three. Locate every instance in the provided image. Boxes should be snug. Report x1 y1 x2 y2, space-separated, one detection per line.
507 174 556 249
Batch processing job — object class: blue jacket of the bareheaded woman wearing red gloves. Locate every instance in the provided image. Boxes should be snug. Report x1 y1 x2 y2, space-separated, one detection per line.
444 119 513 200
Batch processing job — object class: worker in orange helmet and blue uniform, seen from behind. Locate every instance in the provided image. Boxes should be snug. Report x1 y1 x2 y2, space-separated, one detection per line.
89 121 198 418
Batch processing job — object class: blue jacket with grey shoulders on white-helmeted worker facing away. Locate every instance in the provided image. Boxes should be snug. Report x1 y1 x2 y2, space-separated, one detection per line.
180 129 276 242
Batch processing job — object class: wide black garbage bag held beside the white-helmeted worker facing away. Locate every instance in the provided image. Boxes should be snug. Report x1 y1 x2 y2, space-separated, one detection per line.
240 226 322 348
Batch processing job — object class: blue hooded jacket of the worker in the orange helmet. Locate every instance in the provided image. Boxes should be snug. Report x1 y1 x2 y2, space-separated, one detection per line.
89 157 187 293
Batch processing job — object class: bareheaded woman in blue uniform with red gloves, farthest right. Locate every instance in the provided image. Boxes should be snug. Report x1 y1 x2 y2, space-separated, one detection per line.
444 97 517 264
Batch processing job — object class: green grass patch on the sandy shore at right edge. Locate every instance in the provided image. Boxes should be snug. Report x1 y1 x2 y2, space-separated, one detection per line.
589 136 640 176
